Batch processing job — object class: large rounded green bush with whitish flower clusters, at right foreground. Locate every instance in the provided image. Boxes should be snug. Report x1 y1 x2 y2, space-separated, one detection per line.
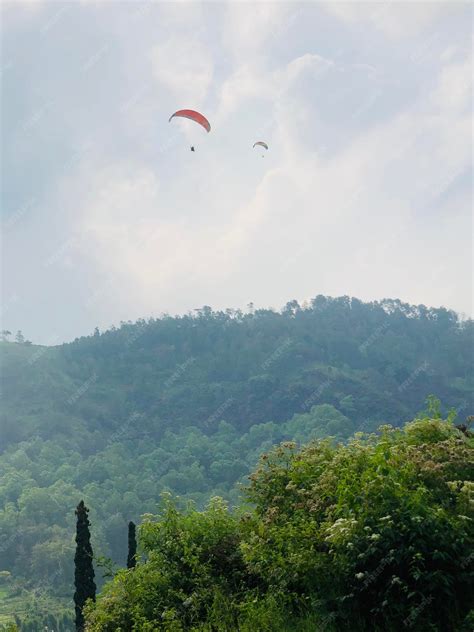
244 419 474 632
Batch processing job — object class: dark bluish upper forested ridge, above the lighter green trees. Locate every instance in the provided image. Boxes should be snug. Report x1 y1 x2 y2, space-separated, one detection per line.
1 296 473 453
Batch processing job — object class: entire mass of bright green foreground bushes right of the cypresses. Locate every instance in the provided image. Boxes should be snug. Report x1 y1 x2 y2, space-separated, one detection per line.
87 418 474 632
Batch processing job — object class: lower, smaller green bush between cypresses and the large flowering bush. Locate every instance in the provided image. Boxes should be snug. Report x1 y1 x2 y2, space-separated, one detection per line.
87 496 255 632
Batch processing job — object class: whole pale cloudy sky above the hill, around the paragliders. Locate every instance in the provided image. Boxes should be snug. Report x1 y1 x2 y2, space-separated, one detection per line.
0 0 473 345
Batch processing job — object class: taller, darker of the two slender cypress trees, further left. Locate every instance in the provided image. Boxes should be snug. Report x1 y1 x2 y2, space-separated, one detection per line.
74 500 96 632
